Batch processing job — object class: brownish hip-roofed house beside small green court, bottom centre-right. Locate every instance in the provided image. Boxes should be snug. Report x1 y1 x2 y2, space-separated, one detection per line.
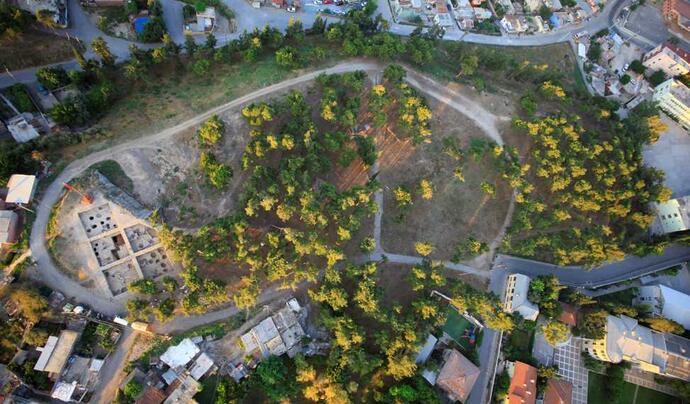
436 349 480 403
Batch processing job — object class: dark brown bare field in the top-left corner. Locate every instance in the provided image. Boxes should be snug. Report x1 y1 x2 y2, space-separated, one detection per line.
0 30 74 70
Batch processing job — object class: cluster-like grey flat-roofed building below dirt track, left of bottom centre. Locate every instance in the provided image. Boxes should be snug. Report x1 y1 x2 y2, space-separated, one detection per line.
240 299 305 358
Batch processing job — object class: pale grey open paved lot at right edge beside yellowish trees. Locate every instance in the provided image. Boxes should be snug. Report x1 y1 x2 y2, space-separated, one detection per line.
643 114 690 198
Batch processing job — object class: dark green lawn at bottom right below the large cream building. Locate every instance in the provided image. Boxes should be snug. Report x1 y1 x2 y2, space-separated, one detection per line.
587 372 679 404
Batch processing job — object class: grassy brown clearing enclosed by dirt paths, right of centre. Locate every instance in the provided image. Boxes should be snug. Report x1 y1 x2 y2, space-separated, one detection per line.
379 95 511 259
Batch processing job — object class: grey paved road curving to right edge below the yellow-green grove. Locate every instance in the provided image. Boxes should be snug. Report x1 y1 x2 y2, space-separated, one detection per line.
494 245 690 288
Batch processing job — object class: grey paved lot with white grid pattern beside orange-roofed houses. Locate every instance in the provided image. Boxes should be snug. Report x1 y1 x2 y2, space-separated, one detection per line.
553 337 588 404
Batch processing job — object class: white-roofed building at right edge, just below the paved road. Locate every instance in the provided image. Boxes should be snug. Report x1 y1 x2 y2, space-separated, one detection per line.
633 285 690 329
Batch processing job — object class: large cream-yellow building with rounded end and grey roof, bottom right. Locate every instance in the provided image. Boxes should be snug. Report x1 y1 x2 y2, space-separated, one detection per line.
584 316 690 381
